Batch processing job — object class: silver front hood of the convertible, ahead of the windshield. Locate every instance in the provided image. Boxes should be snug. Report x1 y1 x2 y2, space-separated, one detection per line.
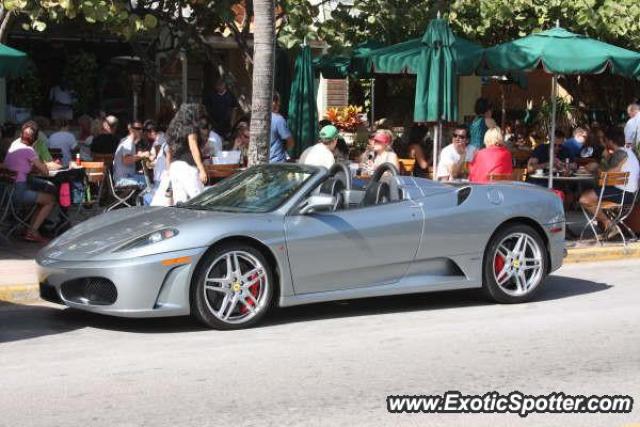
39 207 240 261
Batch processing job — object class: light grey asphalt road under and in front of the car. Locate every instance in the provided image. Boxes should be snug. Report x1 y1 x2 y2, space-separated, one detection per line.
0 261 640 426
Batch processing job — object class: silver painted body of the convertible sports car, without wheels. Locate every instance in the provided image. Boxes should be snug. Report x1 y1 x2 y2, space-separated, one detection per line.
37 169 564 317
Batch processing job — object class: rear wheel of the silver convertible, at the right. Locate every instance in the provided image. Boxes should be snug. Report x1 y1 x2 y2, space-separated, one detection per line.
483 224 548 304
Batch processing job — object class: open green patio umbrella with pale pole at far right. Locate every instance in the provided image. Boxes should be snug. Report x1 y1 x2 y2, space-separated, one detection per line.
483 26 640 188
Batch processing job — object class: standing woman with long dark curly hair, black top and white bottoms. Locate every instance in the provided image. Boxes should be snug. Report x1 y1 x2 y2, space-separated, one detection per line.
166 104 207 203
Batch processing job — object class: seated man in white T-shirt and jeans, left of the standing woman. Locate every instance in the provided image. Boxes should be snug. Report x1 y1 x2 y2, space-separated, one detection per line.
113 121 149 188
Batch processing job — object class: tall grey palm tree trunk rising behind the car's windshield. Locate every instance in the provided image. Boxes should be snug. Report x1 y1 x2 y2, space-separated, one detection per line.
249 0 275 166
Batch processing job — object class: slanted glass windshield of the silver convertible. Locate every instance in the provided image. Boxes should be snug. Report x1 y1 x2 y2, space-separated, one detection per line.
180 164 316 213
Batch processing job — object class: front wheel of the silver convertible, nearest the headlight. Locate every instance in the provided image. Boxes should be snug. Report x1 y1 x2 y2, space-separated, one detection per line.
191 243 275 330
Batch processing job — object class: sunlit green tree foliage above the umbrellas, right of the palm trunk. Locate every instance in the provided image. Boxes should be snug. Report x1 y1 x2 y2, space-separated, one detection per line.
306 0 640 50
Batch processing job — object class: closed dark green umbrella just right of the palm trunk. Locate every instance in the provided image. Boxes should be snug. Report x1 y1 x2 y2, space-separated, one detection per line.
288 45 318 158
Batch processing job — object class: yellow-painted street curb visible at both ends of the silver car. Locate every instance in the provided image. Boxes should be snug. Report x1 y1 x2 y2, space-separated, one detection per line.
0 243 640 304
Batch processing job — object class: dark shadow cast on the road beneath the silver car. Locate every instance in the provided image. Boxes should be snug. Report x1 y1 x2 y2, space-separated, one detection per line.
0 276 611 343
